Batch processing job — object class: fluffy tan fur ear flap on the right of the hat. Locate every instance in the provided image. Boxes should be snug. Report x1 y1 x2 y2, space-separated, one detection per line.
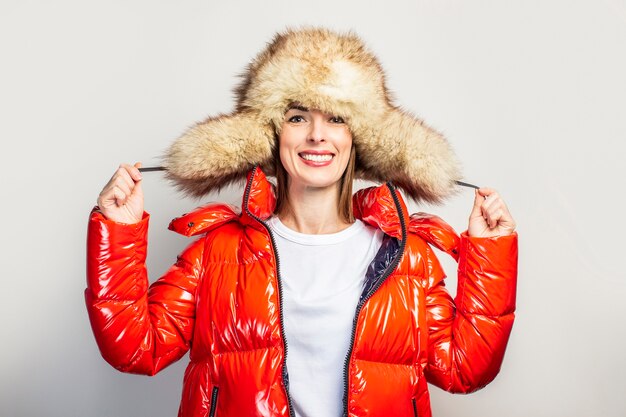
358 107 461 203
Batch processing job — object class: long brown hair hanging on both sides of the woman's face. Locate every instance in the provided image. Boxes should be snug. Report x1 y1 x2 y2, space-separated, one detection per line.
274 143 356 223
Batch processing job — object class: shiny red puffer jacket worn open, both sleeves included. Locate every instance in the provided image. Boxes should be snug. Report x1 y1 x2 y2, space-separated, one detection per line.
85 167 517 417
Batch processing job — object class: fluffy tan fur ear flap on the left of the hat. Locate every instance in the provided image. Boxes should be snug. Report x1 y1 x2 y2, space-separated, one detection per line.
163 111 275 197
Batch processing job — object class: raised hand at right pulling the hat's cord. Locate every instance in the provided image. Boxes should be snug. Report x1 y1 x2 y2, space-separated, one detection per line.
467 187 515 237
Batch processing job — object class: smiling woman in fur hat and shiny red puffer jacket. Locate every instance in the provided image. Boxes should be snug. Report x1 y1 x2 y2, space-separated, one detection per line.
85 29 517 417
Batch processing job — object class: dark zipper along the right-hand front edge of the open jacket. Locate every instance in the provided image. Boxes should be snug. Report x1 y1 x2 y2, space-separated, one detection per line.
343 182 408 417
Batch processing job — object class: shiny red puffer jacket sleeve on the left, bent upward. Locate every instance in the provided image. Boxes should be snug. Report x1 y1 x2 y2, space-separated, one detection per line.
85 209 203 375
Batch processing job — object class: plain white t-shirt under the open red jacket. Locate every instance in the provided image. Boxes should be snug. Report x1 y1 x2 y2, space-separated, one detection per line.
268 217 383 417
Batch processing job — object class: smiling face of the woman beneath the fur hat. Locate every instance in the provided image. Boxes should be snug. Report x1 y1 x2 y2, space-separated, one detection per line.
279 105 352 190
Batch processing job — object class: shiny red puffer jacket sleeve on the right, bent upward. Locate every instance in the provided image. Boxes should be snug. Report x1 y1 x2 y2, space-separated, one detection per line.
425 233 517 393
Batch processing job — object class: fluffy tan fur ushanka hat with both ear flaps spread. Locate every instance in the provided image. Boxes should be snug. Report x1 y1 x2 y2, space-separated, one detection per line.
164 28 460 202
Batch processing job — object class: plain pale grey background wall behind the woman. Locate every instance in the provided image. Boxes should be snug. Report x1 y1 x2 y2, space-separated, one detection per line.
0 0 626 417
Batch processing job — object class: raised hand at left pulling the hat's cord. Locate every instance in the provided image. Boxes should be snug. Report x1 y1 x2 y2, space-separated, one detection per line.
98 162 143 224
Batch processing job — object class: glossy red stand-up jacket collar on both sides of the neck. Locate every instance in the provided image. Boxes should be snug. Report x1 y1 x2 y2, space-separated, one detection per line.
241 166 409 239
